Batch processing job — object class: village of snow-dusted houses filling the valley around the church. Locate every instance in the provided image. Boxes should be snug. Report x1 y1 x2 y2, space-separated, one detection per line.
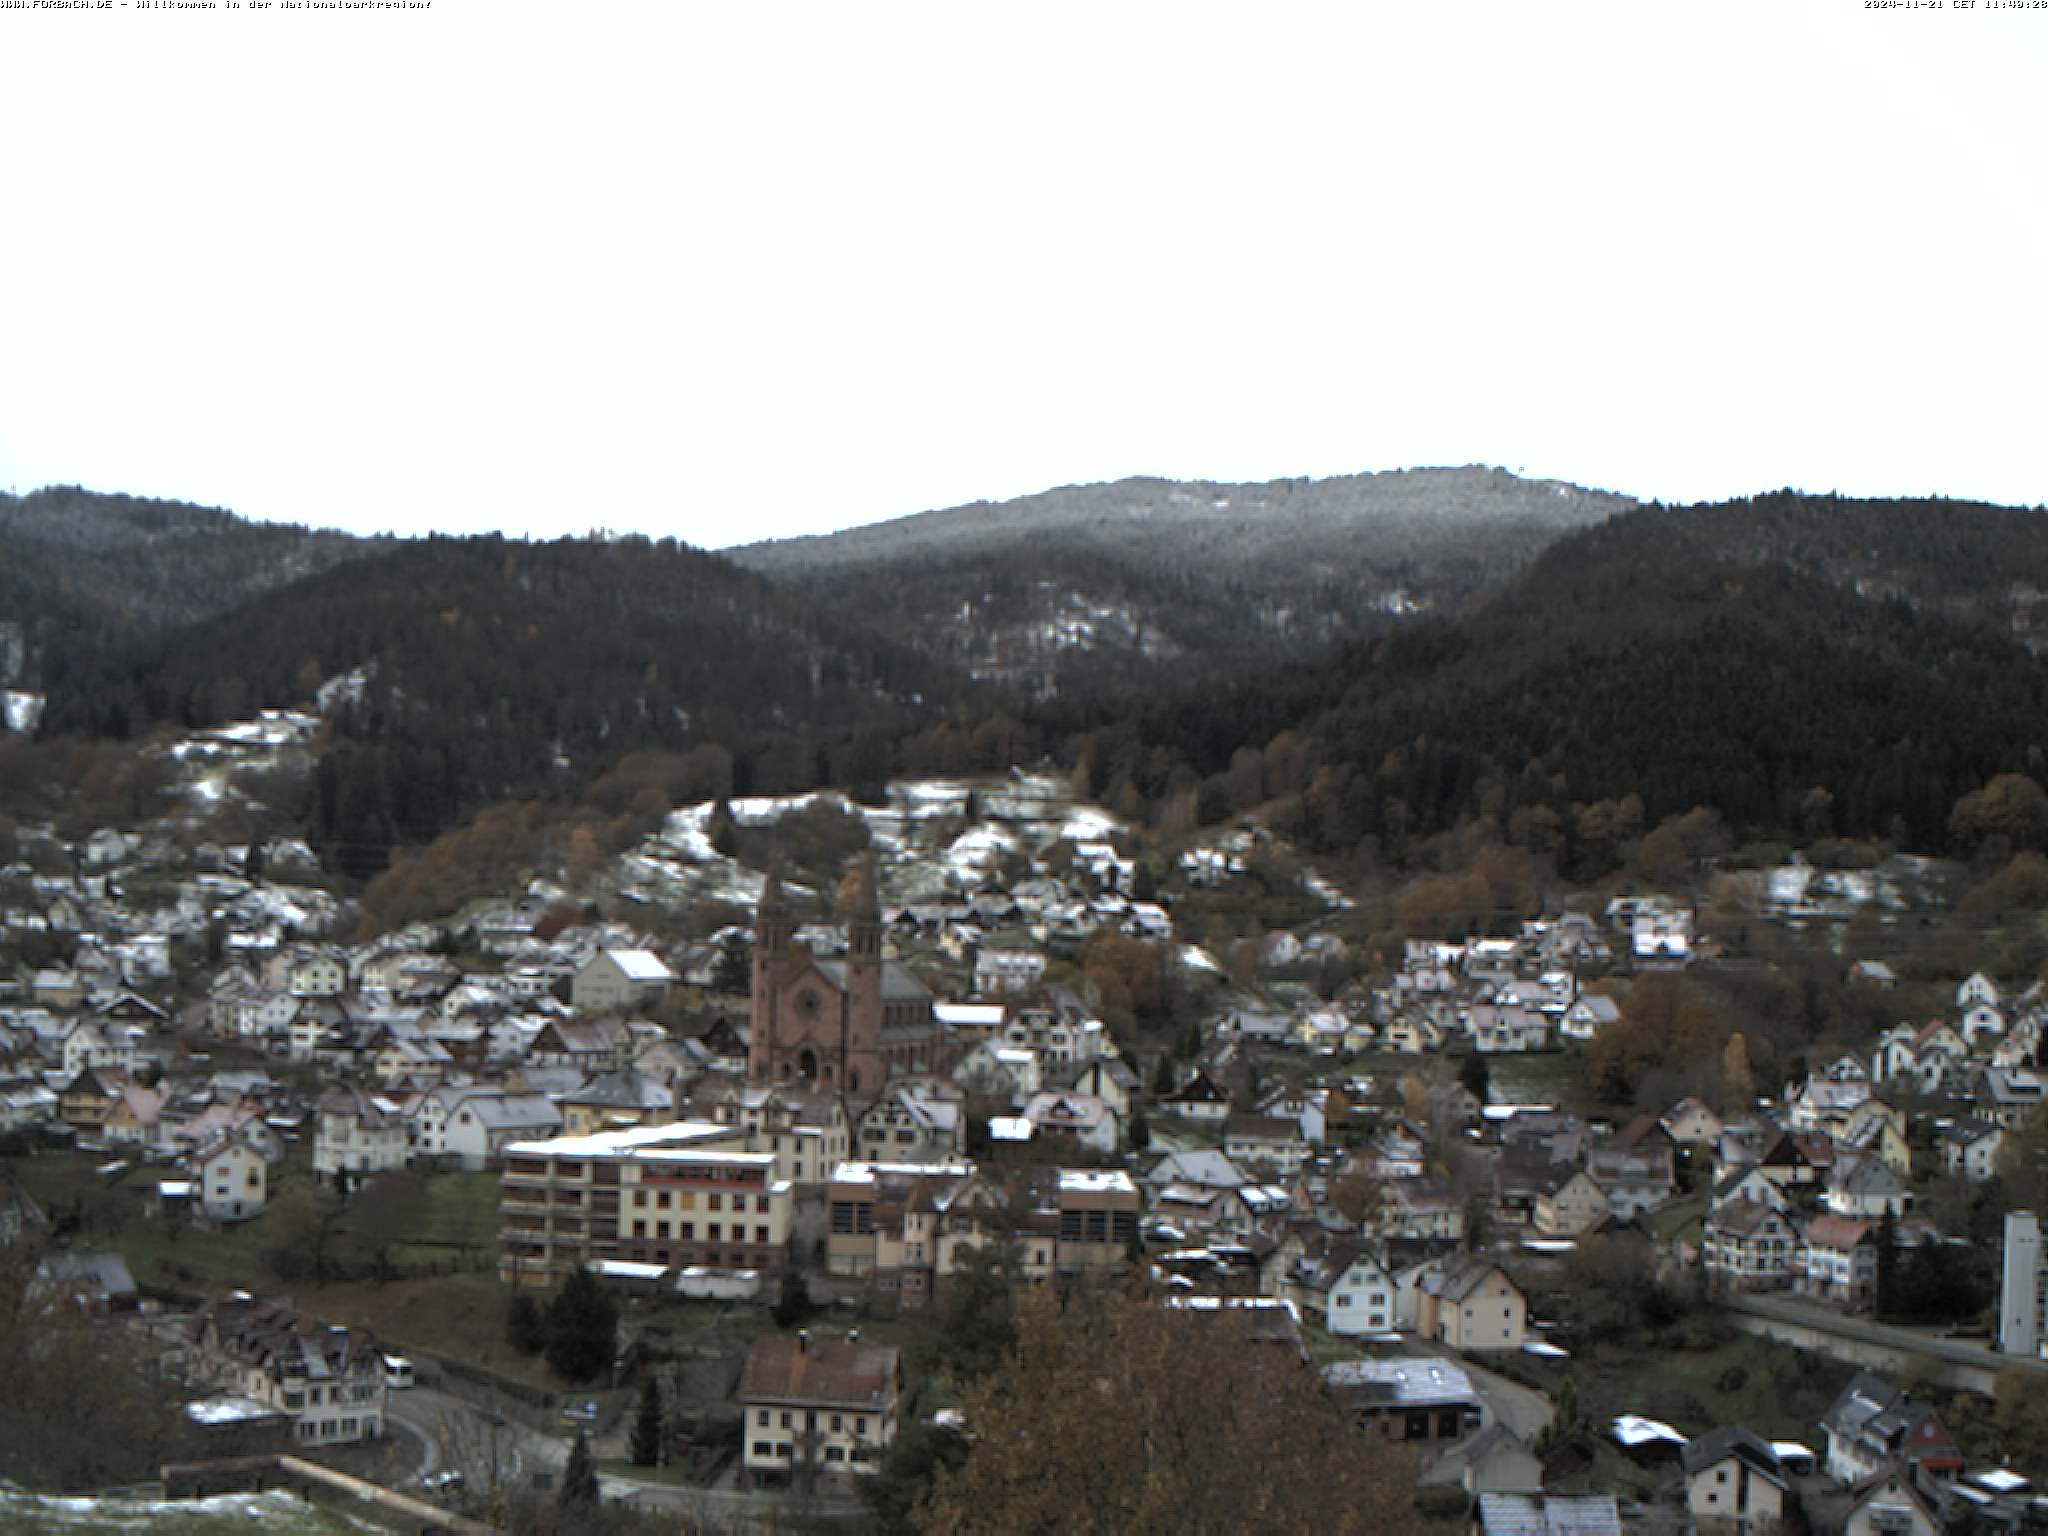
0 765 2048 1536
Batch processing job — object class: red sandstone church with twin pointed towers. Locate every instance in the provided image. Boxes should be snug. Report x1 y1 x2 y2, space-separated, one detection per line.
748 862 958 1102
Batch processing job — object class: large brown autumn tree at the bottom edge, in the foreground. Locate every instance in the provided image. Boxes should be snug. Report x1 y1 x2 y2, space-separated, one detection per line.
920 1286 1421 1536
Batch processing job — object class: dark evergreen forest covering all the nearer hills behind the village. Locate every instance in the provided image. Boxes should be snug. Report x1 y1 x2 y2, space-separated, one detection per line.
0 481 2048 897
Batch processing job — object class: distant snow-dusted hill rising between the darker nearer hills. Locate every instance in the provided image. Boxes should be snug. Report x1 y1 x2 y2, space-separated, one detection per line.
729 467 1634 694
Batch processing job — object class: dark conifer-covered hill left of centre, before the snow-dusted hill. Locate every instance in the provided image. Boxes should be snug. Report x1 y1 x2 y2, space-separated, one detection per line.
32 537 950 872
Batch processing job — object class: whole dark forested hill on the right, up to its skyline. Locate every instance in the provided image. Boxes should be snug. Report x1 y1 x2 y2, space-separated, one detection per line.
1104 494 2048 850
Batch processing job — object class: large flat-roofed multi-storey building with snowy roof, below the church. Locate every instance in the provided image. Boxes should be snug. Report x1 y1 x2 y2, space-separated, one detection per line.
498 1122 795 1286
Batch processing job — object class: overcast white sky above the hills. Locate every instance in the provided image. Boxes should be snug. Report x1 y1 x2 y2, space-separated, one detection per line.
0 0 2048 547
